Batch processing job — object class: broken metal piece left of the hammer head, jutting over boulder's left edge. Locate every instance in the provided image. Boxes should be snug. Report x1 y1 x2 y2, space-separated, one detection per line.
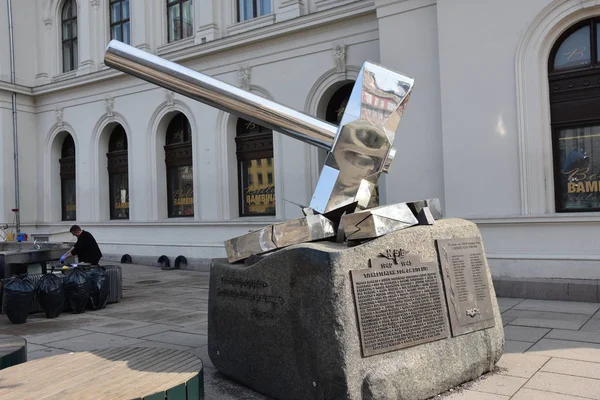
225 215 335 262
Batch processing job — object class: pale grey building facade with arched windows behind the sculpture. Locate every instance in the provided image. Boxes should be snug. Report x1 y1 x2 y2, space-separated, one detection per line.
0 0 600 279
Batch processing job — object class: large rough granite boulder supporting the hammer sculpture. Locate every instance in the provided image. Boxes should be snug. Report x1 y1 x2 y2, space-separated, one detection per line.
208 219 504 400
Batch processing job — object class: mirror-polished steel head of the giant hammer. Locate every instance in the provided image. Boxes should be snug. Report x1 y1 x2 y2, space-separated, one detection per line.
310 62 414 214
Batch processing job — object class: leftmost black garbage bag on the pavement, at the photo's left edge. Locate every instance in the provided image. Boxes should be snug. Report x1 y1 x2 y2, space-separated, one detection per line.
4 274 35 324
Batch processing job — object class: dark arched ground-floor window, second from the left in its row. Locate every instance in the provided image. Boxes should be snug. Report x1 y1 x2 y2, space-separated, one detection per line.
106 125 129 219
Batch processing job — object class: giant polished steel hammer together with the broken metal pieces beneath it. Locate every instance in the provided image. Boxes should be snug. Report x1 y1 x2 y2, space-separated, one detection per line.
104 40 440 262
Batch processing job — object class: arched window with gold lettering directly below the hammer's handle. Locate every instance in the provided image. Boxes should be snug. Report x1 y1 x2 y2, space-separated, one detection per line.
235 118 275 217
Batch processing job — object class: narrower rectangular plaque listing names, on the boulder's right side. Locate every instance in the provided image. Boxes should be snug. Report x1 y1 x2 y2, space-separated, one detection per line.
437 237 495 336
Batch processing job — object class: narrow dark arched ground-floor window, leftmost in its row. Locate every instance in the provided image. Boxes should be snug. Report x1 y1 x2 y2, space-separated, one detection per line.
59 134 77 221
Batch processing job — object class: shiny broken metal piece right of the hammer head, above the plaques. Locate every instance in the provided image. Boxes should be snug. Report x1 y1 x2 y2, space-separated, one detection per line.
342 199 441 241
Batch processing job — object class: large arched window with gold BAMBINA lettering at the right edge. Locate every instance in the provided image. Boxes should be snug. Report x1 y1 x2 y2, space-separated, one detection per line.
548 18 600 212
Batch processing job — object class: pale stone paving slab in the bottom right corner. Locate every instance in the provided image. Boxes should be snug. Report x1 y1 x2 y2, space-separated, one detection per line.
525 372 600 400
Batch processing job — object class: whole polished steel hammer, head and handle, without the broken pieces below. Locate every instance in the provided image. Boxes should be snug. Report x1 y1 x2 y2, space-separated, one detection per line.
104 40 414 214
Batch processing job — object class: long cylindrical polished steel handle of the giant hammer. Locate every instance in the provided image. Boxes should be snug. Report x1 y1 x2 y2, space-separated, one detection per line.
104 40 338 150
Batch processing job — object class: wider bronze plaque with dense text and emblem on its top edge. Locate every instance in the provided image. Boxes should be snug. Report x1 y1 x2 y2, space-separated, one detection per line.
350 250 450 357
